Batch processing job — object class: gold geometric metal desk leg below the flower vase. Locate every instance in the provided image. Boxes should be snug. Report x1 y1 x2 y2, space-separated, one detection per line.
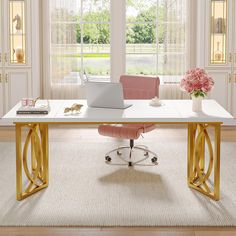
187 123 221 200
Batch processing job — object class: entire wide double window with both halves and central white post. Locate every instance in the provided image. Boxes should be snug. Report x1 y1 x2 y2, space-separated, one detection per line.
43 0 191 99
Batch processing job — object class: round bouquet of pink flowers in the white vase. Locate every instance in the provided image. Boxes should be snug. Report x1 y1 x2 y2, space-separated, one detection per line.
180 68 214 97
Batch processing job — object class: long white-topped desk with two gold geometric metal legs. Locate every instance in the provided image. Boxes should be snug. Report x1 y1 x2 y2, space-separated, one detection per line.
3 100 233 200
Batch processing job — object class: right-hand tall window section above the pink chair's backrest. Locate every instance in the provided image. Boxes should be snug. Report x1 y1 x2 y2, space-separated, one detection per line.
126 0 187 83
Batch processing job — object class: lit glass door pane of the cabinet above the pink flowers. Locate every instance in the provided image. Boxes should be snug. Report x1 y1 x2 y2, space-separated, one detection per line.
210 0 228 64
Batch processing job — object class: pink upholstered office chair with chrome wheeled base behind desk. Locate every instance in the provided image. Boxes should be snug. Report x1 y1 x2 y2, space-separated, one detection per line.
98 75 160 166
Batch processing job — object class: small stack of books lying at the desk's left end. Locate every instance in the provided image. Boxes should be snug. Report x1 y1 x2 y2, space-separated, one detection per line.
16 103 50 115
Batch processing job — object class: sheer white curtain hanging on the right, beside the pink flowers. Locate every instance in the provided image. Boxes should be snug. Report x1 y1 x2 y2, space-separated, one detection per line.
158 0 197 99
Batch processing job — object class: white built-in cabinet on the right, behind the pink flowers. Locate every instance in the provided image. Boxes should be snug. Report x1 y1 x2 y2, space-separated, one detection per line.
197 0 236 117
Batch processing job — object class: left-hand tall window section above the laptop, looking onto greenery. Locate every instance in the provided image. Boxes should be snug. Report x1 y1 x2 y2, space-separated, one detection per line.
50 0 110 84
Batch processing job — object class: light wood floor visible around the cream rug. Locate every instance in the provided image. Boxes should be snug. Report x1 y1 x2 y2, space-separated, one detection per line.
0 126 236 236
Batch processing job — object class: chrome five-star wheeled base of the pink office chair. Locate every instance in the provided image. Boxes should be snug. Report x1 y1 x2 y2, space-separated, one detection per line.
105 145 158 167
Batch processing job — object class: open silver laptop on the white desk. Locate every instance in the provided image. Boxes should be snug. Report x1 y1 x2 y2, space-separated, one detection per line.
85 82 132 109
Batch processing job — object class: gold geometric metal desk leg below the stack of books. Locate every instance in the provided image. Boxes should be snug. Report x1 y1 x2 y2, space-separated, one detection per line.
15 123 48 200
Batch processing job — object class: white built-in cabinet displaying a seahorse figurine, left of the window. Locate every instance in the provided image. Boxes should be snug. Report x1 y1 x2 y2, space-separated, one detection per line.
0 0 40 117
